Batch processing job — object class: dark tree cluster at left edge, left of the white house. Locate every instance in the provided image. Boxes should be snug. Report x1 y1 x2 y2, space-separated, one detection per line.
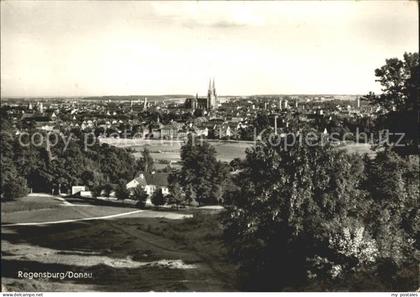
1 112 136 193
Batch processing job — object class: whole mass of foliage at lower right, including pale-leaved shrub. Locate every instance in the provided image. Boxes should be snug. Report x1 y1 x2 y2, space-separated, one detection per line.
224 130 419 291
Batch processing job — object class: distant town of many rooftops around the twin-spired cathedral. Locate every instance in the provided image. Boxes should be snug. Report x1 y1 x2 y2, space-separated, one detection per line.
3 79 368 146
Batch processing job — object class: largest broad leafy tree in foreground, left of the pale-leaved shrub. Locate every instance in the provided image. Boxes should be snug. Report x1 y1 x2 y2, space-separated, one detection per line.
224 133 371 291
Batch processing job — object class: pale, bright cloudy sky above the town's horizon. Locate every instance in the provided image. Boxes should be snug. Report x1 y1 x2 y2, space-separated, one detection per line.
1 0 419 97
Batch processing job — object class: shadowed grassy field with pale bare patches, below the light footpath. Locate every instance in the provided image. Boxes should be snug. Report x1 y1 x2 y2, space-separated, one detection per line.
1 196 235 291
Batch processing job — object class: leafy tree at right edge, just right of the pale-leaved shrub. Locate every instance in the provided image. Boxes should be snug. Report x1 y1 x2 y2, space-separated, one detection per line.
365 152 420 266
